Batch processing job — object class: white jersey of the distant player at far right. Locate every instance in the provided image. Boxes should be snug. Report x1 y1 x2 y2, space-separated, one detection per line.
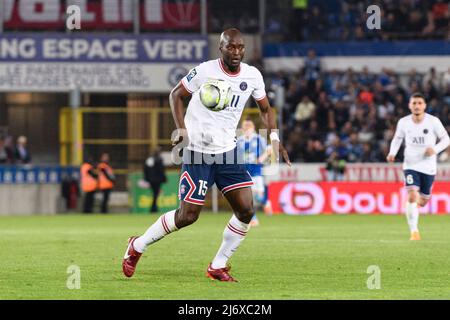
389 113 450 175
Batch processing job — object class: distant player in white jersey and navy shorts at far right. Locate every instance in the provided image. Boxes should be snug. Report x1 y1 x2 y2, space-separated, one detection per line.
387 93 450 240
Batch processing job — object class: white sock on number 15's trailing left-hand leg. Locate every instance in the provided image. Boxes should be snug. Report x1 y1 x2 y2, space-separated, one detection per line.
133 210 178 253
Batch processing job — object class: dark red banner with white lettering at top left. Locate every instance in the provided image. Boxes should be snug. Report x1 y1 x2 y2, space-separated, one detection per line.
2 0 200 31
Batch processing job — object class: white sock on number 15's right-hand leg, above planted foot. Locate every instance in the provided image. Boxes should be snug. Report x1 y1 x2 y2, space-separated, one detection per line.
211 215 250 269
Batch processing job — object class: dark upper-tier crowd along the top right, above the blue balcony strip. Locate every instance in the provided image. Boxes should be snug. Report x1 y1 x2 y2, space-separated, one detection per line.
209 0 450 42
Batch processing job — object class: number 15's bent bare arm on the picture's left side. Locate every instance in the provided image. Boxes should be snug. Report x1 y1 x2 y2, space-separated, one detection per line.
169 81 191 146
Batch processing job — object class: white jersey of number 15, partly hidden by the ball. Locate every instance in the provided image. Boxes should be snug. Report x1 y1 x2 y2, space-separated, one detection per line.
181 59 266 154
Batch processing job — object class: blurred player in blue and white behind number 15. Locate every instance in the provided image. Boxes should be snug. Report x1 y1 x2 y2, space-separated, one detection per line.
237 118 271 226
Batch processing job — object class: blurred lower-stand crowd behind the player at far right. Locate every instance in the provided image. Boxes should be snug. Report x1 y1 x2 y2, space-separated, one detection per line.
266 57 450 162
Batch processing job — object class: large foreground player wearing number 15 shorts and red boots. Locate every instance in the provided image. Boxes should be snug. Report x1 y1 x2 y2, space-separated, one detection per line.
122 28 290 282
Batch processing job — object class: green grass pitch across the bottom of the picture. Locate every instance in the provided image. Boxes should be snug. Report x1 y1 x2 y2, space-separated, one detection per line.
0 213 450 300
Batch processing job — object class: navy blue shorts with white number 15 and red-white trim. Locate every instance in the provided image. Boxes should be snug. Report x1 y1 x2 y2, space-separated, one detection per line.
178 148 253 205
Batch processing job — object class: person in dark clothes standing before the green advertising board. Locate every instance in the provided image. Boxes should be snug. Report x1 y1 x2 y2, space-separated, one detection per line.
143 146 167 212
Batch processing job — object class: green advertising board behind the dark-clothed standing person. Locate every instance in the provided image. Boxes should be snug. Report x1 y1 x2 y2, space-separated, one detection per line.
128 171 180 213
